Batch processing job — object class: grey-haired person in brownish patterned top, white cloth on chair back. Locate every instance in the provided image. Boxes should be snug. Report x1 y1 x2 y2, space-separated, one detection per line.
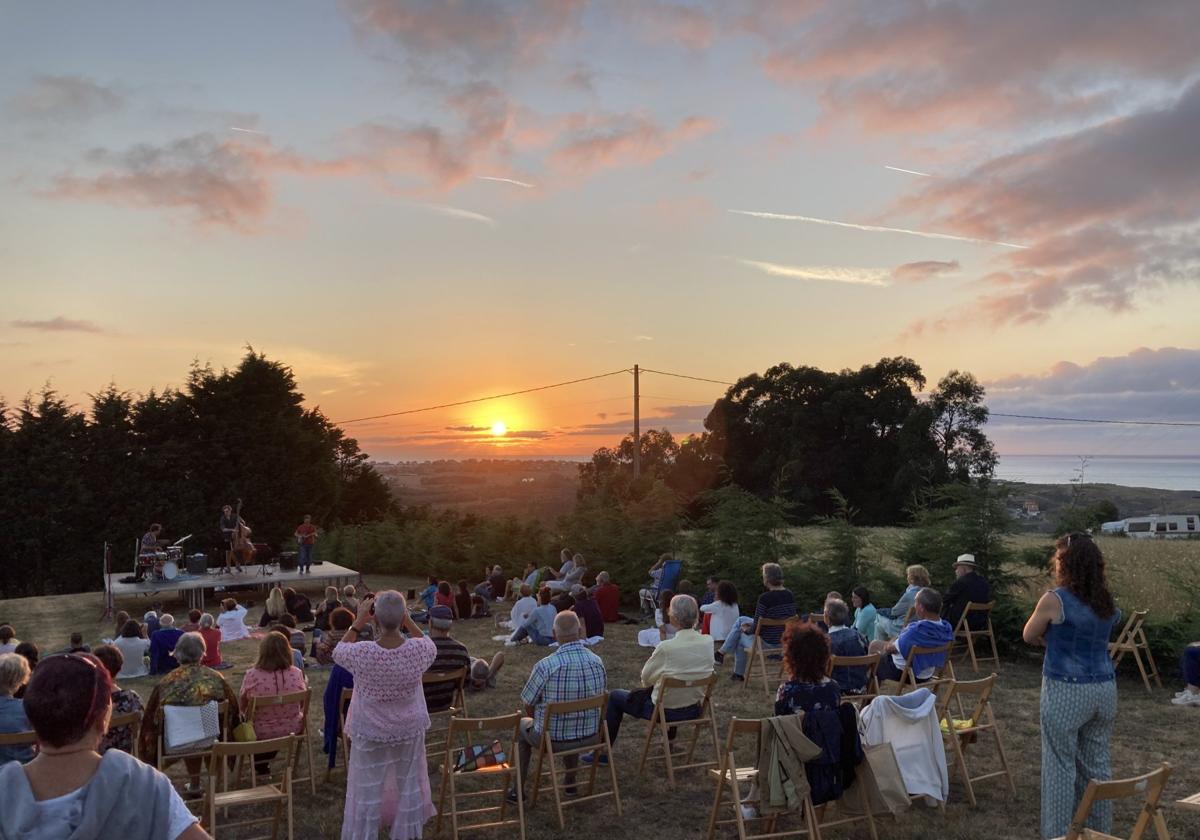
138 632 241 794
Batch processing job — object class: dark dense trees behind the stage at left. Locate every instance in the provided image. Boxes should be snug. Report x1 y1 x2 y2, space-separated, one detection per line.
0 349 392 598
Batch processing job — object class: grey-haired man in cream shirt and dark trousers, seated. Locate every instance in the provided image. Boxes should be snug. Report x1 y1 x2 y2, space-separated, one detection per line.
583 595 714 763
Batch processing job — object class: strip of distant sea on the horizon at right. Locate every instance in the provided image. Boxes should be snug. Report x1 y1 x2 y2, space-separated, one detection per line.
996 455 1200 491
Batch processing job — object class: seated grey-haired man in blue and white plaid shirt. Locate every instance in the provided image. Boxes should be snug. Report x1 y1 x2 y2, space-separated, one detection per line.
508 611 608 802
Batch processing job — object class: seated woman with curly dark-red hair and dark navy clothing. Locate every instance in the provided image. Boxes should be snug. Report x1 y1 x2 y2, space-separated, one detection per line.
775 624 862 804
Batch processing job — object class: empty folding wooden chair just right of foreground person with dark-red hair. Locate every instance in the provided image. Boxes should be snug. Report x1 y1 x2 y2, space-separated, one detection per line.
204 736 296 840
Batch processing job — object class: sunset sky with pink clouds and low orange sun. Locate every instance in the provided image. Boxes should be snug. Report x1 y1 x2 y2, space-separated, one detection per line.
0 0 1200 460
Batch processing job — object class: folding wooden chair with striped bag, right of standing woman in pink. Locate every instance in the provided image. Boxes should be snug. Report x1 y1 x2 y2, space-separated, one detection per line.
434 713 524 840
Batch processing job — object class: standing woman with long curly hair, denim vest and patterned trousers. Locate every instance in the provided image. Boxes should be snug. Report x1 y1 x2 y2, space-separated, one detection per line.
1022 533 1121 838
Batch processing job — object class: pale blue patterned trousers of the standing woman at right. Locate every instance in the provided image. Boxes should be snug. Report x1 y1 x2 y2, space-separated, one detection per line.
1042 677 1117 839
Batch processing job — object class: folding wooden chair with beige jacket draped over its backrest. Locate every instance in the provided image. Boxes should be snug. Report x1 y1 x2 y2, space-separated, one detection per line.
708 718 821 840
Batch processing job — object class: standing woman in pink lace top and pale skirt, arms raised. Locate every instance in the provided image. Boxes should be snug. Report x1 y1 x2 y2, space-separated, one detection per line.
334 589 437 840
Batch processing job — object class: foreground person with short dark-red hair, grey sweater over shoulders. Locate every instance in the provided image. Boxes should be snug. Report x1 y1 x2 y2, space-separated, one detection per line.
0 654 209 840
